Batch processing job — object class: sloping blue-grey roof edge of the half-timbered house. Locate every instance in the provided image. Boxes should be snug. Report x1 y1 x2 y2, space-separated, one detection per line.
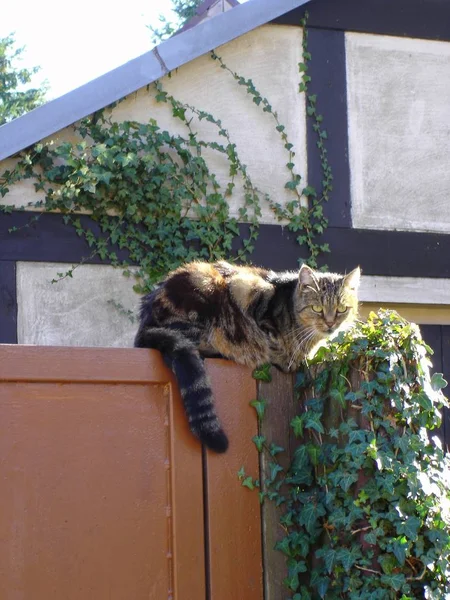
0 0 310 160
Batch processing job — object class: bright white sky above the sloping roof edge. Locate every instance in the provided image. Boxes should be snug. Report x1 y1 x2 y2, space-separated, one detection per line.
0 0 178 100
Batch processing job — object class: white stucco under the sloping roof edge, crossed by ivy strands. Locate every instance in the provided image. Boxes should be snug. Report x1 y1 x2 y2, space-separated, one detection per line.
0 25 307 223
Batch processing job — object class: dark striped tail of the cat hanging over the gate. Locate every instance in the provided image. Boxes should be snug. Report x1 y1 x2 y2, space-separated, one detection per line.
135 327 228 452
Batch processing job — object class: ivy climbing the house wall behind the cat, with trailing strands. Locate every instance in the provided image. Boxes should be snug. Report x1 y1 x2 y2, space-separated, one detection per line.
0 14 332 292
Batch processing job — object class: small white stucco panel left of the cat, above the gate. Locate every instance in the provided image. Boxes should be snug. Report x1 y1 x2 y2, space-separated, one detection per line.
16 262 139 347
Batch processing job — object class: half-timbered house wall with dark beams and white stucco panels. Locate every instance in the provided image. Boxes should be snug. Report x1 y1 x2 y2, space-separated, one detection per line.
0 0 450 356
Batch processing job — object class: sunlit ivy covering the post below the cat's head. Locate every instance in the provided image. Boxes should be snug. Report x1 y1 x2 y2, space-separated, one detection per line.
243 311 450 600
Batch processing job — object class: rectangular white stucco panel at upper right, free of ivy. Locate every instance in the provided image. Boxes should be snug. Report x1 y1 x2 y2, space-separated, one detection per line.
346 33 450 232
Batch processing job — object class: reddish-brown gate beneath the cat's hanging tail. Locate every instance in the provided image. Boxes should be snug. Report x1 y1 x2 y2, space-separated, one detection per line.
0 345 262 600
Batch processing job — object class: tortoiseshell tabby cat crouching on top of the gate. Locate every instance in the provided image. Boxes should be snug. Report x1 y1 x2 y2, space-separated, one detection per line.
134 261 360 452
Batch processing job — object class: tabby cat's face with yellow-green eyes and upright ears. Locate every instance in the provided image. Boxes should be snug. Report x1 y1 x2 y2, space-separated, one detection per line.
295 265 361 338
